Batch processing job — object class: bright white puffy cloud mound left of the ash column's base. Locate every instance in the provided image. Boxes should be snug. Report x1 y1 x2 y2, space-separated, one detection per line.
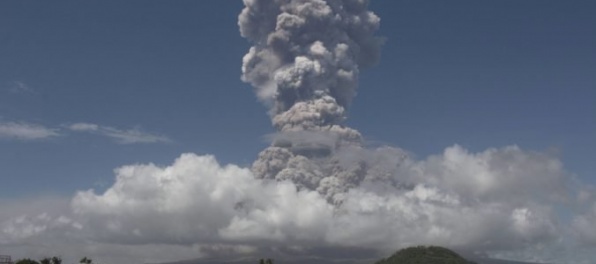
73 154 330 244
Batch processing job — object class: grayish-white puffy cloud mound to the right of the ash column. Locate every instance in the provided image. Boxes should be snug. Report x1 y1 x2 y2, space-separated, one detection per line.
413 145 571 203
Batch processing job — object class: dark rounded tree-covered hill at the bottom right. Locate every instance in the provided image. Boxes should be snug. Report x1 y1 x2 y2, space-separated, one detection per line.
375 246 475 264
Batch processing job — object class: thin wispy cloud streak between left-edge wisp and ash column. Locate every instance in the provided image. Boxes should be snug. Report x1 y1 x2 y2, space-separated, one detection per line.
67 123 172 144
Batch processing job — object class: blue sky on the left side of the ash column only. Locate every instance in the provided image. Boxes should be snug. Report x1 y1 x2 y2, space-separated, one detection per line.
0 1 264 197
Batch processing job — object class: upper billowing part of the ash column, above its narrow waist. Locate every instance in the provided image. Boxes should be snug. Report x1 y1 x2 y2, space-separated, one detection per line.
238 0 381 112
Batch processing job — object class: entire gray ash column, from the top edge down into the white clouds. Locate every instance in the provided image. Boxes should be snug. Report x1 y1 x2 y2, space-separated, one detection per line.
238 0 400 202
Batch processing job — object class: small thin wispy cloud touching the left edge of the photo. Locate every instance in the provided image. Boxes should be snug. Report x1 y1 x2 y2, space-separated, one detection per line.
0 122 60 141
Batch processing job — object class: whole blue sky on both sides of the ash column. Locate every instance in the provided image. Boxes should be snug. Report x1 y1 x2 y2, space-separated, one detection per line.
0 0 596 262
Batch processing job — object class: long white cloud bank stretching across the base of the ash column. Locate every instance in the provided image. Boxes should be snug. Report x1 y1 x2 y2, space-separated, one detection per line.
0 146 596 263
